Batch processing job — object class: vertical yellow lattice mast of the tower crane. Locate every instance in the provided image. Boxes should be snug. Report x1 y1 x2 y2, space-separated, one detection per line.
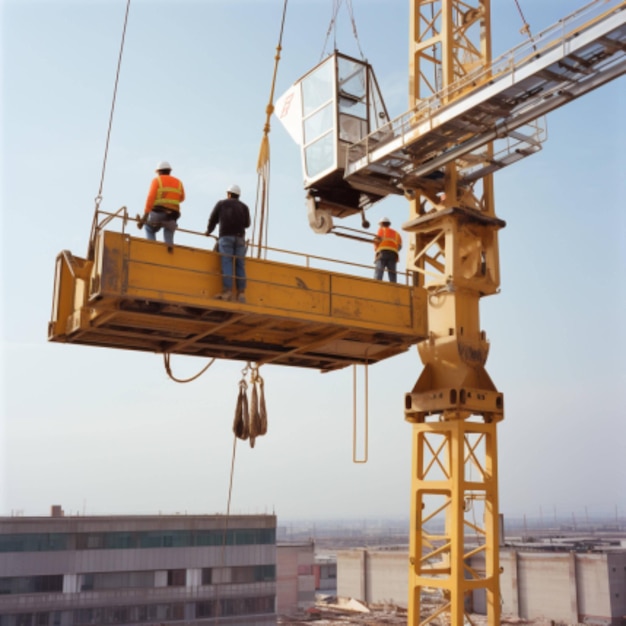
403 0 504 626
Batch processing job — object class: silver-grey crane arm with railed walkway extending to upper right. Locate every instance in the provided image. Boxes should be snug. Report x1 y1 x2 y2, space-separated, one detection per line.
344 0 626 196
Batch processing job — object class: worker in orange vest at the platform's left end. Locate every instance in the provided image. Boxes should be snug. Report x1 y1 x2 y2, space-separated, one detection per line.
144 161 185 252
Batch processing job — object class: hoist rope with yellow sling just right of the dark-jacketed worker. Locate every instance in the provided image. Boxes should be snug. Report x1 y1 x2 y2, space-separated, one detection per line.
252 0 288 257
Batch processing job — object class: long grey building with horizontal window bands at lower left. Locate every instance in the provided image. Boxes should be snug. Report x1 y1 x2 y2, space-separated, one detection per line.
0 509 276 626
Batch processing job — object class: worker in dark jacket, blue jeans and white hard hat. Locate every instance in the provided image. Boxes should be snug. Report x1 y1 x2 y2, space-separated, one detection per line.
205 185 250 302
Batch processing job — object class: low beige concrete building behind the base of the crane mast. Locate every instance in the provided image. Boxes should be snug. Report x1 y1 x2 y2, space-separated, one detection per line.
337 546 626 626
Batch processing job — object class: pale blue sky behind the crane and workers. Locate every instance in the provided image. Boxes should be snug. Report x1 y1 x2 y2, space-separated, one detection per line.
0 0 626 519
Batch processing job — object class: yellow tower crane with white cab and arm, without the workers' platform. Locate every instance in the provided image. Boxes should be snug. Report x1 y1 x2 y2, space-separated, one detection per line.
277 0 626 626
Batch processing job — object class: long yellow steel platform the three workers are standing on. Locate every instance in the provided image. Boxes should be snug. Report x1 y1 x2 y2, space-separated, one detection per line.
48 231 426 371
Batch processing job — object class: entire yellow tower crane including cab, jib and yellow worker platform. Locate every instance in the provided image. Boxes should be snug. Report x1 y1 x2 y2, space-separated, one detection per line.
48 0 626 626
